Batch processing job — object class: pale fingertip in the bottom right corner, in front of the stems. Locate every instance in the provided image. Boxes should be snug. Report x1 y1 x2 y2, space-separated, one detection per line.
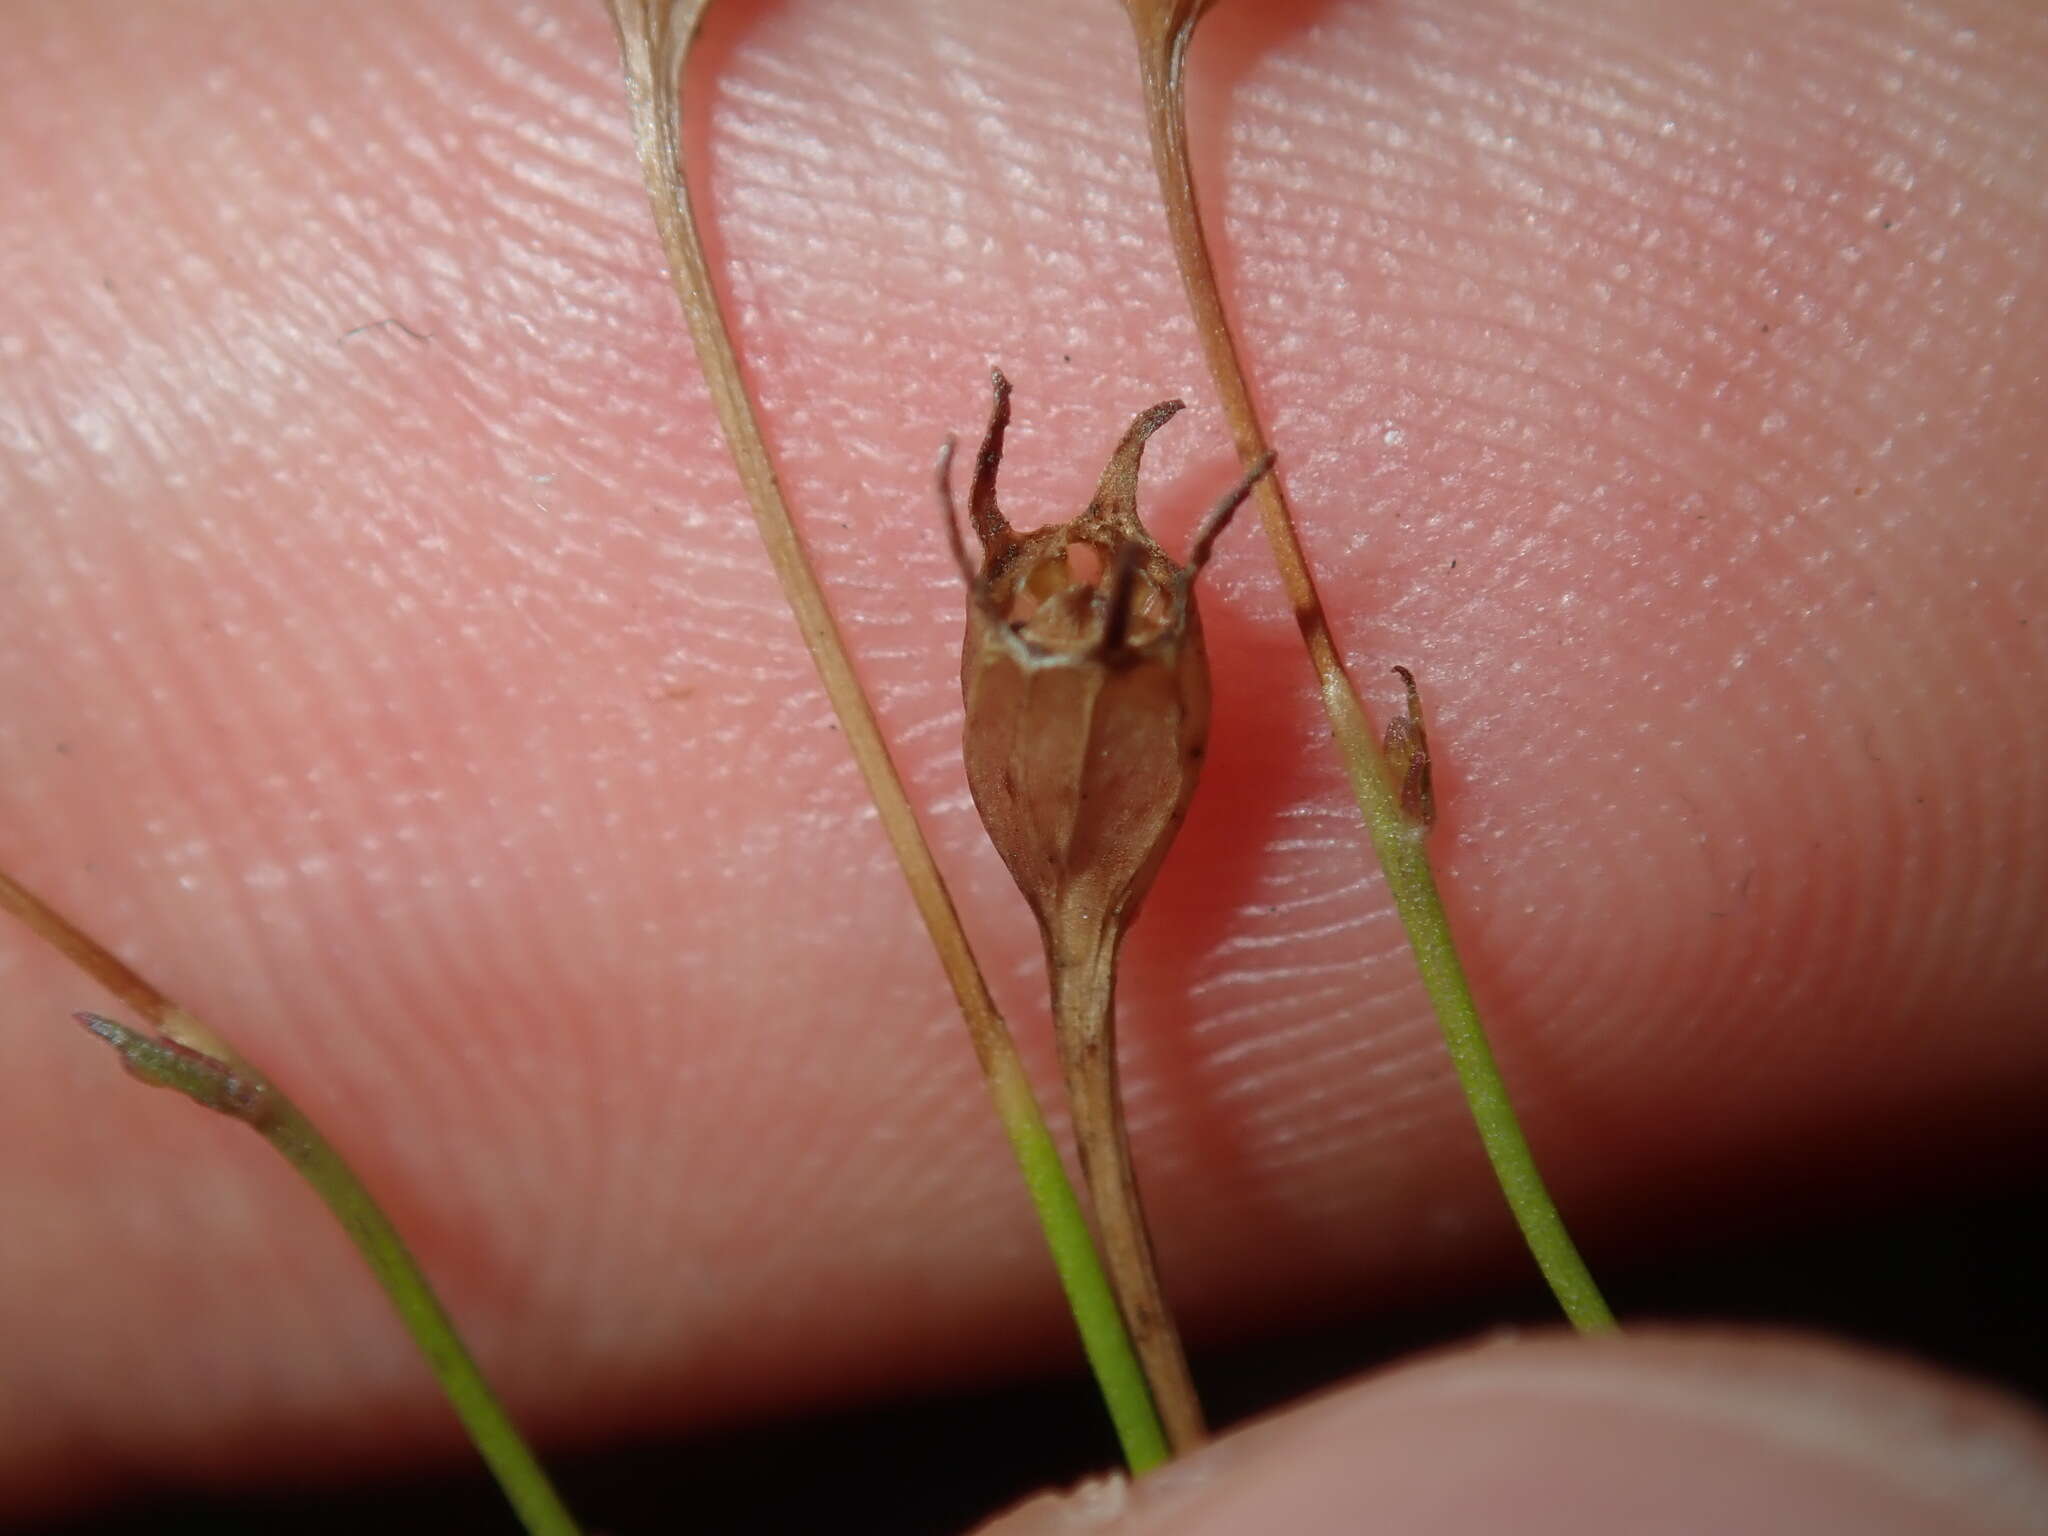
981 1329 2048 1536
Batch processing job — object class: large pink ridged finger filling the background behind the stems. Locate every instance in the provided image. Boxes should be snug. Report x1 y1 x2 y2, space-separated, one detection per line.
0 0 2048 1511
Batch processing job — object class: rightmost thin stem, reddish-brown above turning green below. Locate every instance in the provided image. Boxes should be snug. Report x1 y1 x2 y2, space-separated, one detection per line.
1124 0 1614 1331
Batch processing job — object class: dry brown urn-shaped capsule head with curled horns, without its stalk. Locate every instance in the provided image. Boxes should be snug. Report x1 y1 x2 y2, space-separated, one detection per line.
946 373 1268 958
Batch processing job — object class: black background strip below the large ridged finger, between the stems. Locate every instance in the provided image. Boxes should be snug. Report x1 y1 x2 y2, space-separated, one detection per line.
35 1174 2048 1536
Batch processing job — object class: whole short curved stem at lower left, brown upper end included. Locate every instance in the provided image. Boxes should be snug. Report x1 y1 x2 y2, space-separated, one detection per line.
0 870 578 1536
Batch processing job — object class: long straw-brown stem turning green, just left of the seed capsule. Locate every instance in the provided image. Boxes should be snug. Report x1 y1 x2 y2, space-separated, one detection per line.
610 0 1167 1473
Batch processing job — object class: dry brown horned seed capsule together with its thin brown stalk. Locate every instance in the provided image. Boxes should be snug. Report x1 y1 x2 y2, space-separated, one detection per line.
940 373 1272 1448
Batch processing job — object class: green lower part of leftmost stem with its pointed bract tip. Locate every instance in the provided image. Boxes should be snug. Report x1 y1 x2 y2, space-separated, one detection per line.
78 1014 578 1536
